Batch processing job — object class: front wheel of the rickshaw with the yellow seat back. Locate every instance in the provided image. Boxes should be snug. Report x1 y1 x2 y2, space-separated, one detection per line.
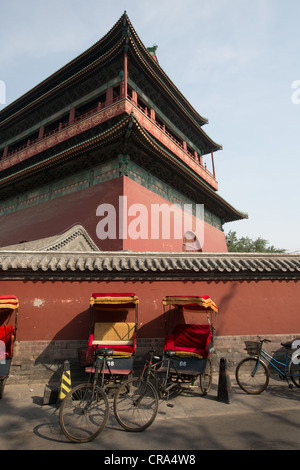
59 383 109 442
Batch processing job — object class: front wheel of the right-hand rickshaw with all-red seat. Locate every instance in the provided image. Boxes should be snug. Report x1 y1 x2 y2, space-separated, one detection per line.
114 377 158 432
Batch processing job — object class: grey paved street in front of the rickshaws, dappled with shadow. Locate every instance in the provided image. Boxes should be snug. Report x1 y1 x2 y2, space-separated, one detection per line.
0 374 300 452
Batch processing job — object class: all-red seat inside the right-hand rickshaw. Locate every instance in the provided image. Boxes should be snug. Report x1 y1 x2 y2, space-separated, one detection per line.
164 324 212 357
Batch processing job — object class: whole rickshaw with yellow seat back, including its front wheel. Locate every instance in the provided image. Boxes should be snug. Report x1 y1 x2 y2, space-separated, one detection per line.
59 293 139 442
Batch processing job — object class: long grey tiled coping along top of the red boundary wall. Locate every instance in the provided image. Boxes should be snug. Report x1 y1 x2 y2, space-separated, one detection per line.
0 250 300 280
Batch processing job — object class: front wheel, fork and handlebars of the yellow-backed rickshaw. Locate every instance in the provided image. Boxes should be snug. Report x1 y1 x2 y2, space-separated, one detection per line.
59 348 122 443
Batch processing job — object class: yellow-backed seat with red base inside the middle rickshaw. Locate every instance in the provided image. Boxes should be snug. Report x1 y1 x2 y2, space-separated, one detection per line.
89 322 136 356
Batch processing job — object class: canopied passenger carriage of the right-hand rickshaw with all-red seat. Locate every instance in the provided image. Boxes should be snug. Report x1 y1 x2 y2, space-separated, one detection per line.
160 295 218 395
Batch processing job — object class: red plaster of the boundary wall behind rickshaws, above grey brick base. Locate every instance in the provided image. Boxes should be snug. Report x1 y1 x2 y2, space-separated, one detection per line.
1 281 300 341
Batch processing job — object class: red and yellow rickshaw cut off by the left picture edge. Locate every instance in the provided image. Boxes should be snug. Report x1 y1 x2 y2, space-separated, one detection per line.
0 295 19 398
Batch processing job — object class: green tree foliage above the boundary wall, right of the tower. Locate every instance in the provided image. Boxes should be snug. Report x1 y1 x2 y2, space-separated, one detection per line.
226 230 286 253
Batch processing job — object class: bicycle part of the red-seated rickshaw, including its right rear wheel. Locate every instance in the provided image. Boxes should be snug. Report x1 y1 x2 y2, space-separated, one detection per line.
114 348 212 432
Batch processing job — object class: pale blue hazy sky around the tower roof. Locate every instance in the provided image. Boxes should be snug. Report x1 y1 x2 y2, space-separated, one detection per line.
0 0 300 252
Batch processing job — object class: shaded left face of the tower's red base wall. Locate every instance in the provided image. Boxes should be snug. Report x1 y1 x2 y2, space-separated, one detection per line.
0 177 123 251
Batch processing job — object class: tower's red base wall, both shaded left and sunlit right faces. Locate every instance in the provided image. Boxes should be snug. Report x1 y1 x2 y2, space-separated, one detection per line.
0 177 227 252
